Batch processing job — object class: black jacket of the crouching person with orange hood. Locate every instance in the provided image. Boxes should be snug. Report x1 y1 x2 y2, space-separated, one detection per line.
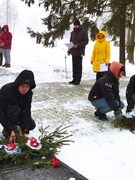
88 71 120 111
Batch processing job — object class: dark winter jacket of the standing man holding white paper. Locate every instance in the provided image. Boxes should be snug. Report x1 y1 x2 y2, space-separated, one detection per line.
70 26 89 56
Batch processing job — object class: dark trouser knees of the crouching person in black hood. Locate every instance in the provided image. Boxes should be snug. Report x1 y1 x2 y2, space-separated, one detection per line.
7 105 36 130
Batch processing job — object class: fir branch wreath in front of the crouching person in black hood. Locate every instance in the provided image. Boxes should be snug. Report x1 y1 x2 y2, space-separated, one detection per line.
0 126 73 175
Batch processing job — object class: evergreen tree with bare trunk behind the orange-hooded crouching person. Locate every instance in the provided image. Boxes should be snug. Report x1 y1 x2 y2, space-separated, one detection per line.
104 0 134 64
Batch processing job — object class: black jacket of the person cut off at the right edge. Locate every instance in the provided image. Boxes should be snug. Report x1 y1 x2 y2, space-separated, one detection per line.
126 75 135 112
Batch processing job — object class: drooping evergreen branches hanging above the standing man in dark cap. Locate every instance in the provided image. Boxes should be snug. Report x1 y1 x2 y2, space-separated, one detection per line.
22 0 107 47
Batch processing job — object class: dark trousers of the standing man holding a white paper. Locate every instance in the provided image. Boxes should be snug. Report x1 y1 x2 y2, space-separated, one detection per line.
72 56 82 83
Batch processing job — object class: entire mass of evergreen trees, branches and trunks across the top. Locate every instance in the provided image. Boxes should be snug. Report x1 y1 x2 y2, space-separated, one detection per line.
21 0 135 68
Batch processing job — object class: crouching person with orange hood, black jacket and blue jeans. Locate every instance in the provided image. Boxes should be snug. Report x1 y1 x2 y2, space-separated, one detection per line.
88 62 125 120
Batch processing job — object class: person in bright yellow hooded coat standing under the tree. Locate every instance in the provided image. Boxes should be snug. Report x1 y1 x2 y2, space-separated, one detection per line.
90 30 110 80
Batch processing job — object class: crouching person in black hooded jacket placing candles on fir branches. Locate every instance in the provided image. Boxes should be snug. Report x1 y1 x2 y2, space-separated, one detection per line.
0 70 36 143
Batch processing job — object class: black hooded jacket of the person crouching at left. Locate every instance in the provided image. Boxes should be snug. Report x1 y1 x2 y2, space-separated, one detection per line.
0 70 36 134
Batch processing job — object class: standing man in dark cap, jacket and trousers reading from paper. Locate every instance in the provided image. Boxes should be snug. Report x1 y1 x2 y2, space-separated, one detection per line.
68 19 89 85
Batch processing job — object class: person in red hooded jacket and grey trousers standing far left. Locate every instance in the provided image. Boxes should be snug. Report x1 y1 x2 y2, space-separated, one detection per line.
0 25 12 68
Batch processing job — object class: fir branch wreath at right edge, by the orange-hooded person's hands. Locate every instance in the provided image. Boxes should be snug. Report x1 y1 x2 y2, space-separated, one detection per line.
114 116 135 134
